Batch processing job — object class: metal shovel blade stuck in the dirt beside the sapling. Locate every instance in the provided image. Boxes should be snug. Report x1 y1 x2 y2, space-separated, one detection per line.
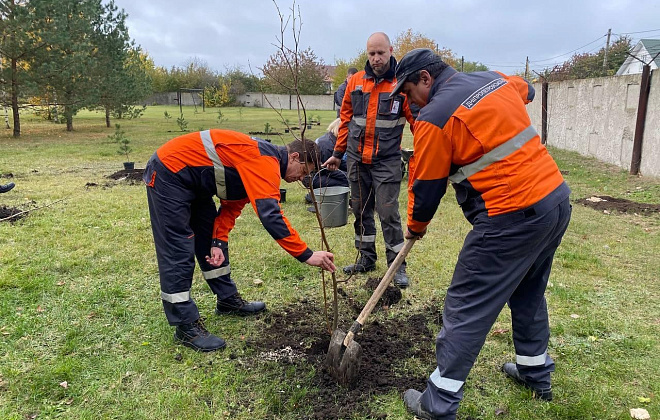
325 329 362 385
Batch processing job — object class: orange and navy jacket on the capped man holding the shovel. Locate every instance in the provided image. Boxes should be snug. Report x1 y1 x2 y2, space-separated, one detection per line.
408 67 563 233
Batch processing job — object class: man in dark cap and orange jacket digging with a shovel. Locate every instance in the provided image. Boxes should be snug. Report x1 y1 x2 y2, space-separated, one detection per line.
392 49 571 420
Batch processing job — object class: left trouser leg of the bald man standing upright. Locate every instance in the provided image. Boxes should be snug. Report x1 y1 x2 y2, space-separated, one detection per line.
348 160 377 261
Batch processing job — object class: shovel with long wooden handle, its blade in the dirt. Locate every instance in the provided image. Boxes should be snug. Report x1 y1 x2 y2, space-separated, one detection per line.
325 238 417 385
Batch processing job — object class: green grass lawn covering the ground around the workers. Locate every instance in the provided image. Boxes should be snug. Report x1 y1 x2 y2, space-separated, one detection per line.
0 107 660 420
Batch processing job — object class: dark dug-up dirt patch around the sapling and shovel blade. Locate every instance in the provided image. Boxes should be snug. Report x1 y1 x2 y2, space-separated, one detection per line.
245 296 442 419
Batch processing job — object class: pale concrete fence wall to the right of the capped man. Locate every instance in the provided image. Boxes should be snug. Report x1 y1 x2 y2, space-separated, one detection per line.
527 71 660 177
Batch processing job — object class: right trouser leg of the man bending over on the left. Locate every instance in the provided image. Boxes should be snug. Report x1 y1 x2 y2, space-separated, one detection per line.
190 197 237 299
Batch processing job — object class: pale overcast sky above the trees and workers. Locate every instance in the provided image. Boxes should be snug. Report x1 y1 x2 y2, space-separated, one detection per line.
115 0 660 73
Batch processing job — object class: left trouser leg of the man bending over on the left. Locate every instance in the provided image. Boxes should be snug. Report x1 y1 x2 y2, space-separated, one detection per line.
147 161 199 325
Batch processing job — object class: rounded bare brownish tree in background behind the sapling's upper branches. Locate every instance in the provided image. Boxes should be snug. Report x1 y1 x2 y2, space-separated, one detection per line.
260 48 327 95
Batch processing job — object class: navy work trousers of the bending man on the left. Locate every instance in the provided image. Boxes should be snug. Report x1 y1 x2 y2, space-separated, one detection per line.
143 155 237 325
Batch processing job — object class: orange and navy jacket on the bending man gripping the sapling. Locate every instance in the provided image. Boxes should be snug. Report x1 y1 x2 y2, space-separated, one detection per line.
156 130 312 262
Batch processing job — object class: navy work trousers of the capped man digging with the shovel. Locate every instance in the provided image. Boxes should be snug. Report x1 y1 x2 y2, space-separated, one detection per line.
421 184 571 419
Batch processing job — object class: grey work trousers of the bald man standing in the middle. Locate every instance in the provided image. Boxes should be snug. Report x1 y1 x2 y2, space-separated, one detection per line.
347 157 405 266
